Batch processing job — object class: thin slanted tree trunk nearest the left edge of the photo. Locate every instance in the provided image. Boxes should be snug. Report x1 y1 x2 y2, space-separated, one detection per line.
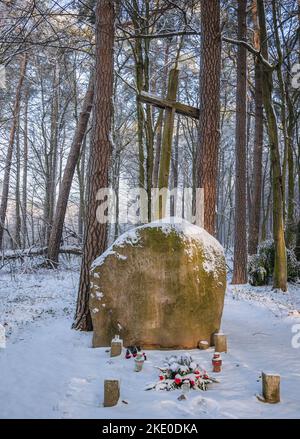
0 53 27 249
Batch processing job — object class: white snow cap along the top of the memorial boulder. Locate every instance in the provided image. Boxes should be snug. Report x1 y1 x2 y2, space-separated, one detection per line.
91 217 224 271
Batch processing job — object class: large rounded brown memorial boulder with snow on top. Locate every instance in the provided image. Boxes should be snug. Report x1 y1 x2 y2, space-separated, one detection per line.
90 218 226 349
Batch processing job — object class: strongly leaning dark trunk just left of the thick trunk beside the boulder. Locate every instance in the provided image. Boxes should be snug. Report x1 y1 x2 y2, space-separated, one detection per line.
48 75 94 266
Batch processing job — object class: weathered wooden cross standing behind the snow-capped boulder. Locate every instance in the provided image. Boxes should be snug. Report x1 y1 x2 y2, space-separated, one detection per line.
138 68 200 219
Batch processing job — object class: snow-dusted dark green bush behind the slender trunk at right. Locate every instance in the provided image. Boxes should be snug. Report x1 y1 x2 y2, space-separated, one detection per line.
248 241 300 286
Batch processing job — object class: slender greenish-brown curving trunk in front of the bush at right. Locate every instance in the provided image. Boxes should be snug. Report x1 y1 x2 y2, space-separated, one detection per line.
257 0 287 291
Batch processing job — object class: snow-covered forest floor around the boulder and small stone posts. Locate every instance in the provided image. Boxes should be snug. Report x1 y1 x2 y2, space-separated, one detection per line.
0 267 300 419
